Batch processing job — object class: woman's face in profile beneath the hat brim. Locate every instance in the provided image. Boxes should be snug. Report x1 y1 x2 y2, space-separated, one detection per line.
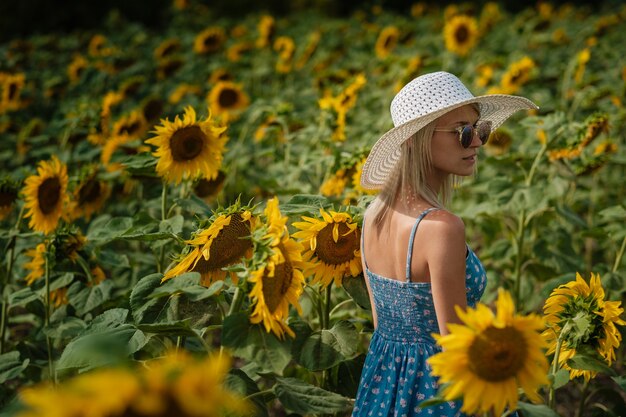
430 105 482 176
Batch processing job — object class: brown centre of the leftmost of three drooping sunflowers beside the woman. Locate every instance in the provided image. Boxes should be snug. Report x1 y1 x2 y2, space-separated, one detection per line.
198 213 252 272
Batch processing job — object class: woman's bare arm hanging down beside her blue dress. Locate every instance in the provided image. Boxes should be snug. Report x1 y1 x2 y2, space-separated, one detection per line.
424 211 467 335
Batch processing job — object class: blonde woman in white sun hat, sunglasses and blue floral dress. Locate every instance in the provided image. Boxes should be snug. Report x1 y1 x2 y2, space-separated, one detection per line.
353 72 537 417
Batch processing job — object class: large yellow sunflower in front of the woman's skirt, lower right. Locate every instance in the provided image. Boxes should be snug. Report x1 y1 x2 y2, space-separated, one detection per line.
428 289 548 416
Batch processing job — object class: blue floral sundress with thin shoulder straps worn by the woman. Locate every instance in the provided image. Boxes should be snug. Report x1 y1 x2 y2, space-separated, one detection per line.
352 208 487 417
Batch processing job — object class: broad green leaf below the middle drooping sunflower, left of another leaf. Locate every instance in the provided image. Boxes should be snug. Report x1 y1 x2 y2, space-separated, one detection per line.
222 312 291 375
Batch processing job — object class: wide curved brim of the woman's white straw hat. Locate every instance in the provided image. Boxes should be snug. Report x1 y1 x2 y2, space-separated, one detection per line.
361 94 539 190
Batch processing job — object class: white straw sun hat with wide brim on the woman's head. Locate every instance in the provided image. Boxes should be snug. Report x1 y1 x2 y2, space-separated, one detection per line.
361 71 539 189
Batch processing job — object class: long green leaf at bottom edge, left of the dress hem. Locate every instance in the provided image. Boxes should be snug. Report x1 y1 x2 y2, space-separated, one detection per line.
273 378 354 414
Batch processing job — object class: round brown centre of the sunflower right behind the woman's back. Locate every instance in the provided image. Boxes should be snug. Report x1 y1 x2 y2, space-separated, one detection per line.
315 223 359 265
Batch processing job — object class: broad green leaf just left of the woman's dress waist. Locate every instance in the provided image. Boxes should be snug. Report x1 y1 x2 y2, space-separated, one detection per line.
295 321 359 371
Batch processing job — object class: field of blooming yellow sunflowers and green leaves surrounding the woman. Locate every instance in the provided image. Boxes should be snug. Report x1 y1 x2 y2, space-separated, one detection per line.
0 0 626 417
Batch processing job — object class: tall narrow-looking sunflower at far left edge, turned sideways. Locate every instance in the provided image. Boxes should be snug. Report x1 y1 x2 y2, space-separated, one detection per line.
22 156 68 234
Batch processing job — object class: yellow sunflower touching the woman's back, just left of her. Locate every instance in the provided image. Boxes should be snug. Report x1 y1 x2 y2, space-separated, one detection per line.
293 209 362 287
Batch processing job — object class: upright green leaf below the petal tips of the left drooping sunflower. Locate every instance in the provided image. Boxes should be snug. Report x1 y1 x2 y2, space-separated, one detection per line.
130 273 169 324
